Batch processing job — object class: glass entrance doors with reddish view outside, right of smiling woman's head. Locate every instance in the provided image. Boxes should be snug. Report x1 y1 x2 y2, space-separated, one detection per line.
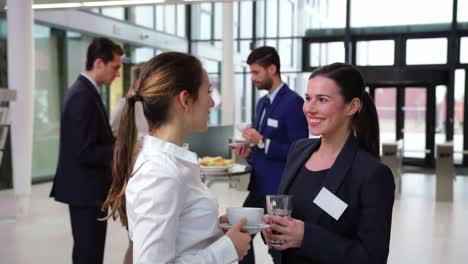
370 85 436 166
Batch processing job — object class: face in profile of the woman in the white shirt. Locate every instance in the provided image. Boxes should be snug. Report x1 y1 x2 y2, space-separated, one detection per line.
190 70 214 132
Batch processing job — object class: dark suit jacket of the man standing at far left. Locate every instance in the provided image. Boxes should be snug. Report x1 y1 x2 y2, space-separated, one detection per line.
50 75 114 206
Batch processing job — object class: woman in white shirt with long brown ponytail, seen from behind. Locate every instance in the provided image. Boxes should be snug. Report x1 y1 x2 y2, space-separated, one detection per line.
103 52 250 264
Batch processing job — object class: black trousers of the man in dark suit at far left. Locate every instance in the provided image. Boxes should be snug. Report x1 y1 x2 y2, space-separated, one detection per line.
69 205 107 264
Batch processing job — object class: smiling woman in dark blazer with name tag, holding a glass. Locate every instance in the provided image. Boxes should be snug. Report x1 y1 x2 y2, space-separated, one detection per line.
263 63 395 264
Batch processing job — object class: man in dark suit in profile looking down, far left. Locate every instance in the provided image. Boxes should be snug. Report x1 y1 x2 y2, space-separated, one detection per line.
50 38 123 264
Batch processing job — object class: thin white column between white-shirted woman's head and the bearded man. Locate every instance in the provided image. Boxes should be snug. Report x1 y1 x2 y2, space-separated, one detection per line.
221 2 235 125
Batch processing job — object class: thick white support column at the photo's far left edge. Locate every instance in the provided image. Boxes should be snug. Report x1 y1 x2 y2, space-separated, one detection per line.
7 0 34 217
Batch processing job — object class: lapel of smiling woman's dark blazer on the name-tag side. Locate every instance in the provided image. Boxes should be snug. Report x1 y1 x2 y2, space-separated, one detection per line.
309 134 358 223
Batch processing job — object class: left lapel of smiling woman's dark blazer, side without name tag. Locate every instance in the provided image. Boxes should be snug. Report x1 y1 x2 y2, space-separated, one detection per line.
279 139 320 194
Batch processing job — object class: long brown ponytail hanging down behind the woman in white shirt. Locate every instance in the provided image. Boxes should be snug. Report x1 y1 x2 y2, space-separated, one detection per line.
102 94 142 227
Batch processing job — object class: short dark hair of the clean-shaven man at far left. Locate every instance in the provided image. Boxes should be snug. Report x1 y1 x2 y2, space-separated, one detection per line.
86 38 123 71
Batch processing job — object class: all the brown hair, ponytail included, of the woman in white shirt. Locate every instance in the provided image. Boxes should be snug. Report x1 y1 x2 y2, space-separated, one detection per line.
102 52 203 226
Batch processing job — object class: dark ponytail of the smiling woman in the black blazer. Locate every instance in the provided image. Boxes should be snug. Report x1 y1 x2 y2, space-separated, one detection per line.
353 91 380 159
